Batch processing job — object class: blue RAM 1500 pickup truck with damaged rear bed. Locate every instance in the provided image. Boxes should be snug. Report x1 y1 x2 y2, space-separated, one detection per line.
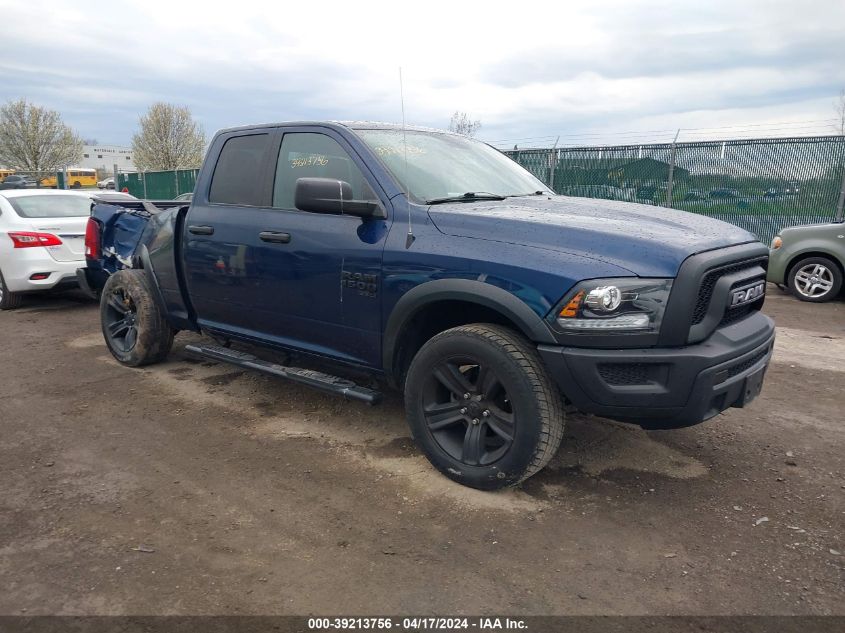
79 122 774 489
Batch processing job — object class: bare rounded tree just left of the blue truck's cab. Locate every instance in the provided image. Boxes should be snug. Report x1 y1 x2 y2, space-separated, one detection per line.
132 103 205 171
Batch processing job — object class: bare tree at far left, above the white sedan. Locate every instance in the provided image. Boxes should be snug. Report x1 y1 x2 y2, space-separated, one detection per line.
0 99 82 178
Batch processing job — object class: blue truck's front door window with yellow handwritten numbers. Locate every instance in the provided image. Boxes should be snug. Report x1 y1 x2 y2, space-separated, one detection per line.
273 132 375 209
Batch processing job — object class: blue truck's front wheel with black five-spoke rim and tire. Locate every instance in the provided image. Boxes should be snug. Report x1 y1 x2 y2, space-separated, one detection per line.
405 324 564 490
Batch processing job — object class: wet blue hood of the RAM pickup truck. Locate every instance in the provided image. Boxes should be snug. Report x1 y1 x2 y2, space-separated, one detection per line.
428 196 757 277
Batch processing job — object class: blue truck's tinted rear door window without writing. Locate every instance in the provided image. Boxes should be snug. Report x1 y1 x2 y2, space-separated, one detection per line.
208 134 270 207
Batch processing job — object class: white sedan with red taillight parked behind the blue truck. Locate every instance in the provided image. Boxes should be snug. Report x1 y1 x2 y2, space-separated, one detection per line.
0 189 132 310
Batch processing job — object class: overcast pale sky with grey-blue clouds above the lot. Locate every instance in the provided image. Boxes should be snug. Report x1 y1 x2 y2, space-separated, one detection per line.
0 0 845 146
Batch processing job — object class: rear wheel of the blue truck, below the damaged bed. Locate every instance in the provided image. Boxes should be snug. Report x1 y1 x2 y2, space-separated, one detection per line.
100 270 174 367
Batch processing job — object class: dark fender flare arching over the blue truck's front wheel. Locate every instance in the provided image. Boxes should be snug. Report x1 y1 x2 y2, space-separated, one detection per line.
382 279 557 376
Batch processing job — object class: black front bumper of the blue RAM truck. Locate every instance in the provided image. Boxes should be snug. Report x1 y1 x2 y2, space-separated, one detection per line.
538 312 775 429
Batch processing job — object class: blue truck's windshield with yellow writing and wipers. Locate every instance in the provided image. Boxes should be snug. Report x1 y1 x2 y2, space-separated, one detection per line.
355 129 549 203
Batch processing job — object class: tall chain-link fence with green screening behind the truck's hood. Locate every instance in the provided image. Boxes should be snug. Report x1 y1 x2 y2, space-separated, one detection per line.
505 136 845 243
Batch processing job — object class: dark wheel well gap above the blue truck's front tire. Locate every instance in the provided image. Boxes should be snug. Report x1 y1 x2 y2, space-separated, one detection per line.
391 300 524 387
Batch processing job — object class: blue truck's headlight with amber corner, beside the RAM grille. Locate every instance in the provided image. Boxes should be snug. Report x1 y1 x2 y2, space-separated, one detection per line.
555 279 672 334
